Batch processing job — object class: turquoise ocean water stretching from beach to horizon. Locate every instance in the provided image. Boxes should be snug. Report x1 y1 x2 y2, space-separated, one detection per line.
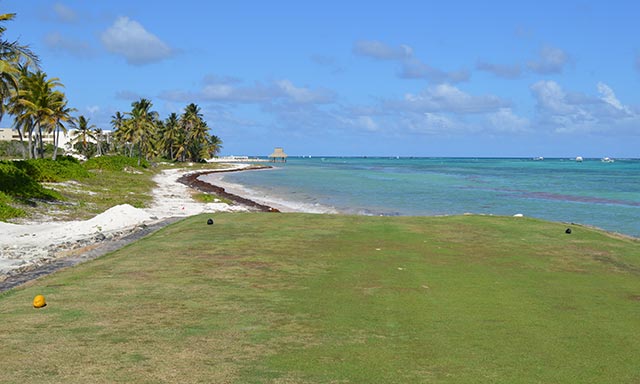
216 158 640 237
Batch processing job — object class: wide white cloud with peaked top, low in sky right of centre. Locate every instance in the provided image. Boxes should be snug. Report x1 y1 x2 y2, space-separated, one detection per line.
388 84 509 114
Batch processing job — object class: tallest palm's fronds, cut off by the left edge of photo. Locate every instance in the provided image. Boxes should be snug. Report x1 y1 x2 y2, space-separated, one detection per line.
0 13 38 120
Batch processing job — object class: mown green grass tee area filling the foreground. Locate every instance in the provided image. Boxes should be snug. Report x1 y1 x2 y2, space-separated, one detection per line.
0 213 640 384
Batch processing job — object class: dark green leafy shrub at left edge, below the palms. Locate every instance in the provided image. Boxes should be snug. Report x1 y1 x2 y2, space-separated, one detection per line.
0 161 62 200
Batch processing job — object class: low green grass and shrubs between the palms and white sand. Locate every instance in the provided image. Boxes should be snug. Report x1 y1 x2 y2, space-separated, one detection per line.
0 156 232 221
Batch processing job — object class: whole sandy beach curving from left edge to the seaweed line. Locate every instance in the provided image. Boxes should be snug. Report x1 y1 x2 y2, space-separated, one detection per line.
0 163 279 292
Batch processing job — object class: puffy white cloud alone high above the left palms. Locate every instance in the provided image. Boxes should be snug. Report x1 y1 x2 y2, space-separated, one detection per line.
101 17 173 65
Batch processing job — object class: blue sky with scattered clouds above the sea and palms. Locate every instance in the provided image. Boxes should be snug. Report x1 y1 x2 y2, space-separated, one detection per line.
5 0 640 158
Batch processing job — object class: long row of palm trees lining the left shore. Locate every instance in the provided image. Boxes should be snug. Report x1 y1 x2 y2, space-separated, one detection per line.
0 13 222 163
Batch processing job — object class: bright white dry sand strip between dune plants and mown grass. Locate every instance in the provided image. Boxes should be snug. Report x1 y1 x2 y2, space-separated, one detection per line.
0 164 255 280
